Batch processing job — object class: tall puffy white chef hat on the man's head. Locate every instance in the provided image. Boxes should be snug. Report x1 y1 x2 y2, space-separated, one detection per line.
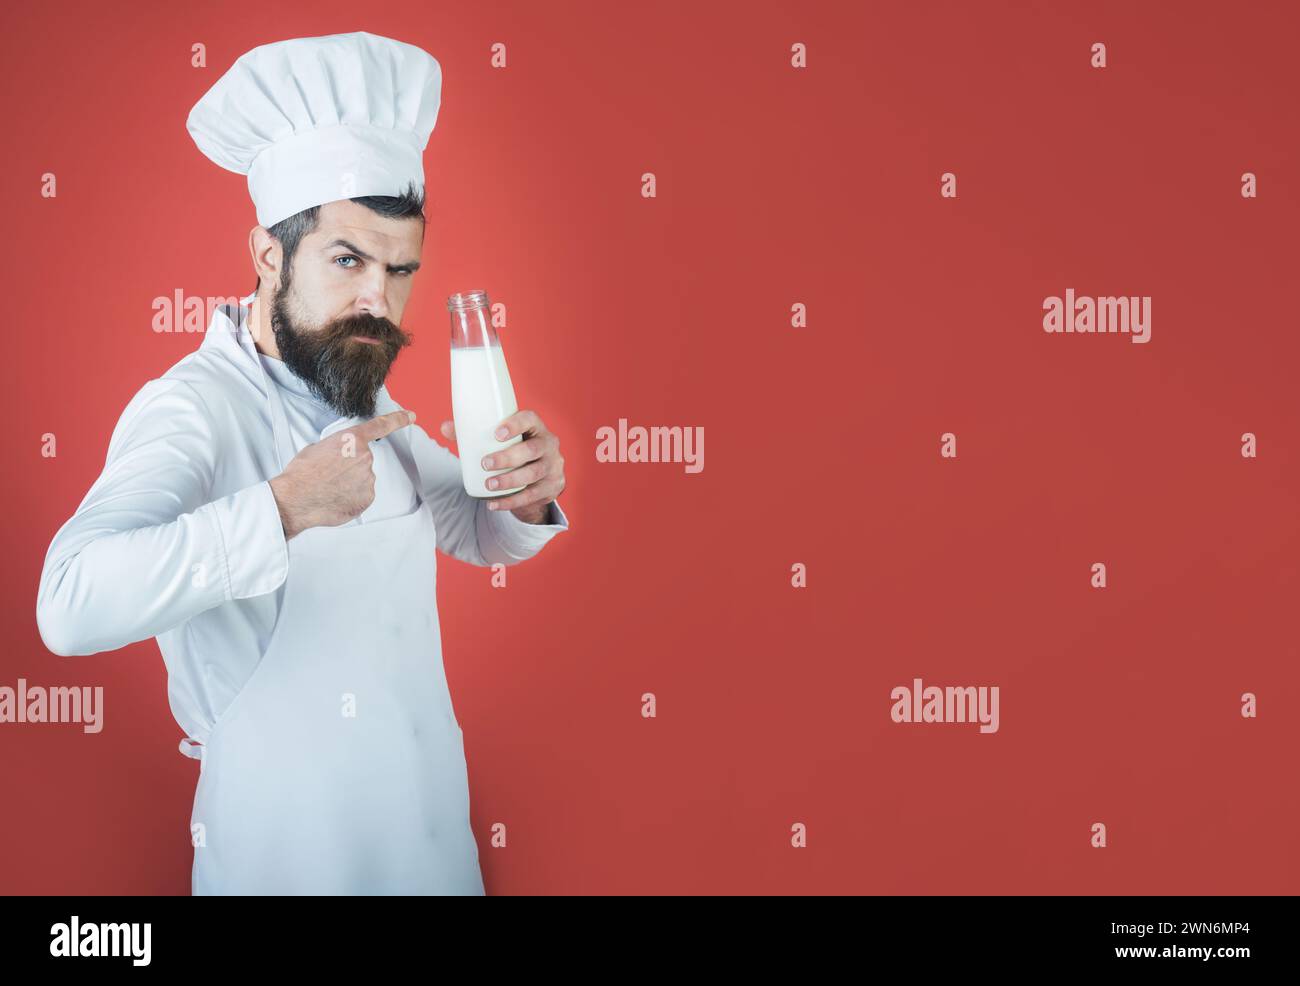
186 31 442 226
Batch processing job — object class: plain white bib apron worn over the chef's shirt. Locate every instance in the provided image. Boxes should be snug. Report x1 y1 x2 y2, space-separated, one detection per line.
182 366 484 895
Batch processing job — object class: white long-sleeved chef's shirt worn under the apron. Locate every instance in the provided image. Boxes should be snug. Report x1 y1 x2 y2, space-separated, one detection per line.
36 295 568 754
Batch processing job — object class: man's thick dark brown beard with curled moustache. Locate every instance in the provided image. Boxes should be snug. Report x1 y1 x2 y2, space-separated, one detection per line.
270 287 411 418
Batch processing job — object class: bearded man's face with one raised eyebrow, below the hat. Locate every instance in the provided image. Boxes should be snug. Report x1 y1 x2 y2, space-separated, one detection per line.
270 199 424 418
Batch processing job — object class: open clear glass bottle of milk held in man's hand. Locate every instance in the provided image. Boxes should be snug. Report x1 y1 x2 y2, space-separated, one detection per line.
447 291 524 498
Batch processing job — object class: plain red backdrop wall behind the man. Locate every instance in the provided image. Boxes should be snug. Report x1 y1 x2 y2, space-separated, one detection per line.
0 0 1300 894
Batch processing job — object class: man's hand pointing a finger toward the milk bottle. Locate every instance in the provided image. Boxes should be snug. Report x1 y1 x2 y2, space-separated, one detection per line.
270 410 415 541
